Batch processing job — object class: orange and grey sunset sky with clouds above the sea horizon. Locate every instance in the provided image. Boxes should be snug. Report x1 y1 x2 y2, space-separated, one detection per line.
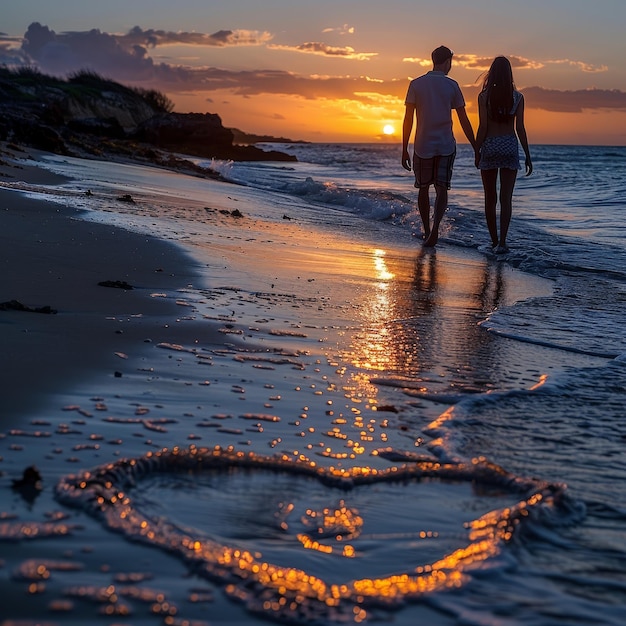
0 0 626 145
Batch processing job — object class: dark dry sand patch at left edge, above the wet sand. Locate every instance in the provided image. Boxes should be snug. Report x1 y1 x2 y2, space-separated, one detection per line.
0 147 207 424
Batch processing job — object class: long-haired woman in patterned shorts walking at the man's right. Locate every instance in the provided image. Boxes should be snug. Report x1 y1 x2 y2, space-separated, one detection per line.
476 56 533 254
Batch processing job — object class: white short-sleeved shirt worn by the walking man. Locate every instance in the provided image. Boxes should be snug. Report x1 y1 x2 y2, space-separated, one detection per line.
405 70 465 159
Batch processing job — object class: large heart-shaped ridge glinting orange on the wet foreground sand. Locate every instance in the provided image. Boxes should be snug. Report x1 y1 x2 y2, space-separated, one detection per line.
56 446 565 623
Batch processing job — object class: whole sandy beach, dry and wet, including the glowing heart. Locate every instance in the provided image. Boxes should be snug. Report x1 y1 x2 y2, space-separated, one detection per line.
0 143 617 625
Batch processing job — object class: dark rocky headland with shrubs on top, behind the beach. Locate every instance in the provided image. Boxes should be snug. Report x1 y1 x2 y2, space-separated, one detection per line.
0 68 296 161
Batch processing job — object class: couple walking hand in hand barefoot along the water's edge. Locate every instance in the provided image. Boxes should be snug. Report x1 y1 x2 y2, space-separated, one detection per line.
402 46 533 254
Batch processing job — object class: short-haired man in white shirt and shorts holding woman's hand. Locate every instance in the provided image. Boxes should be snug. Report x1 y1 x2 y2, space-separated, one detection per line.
402 46 476 247
